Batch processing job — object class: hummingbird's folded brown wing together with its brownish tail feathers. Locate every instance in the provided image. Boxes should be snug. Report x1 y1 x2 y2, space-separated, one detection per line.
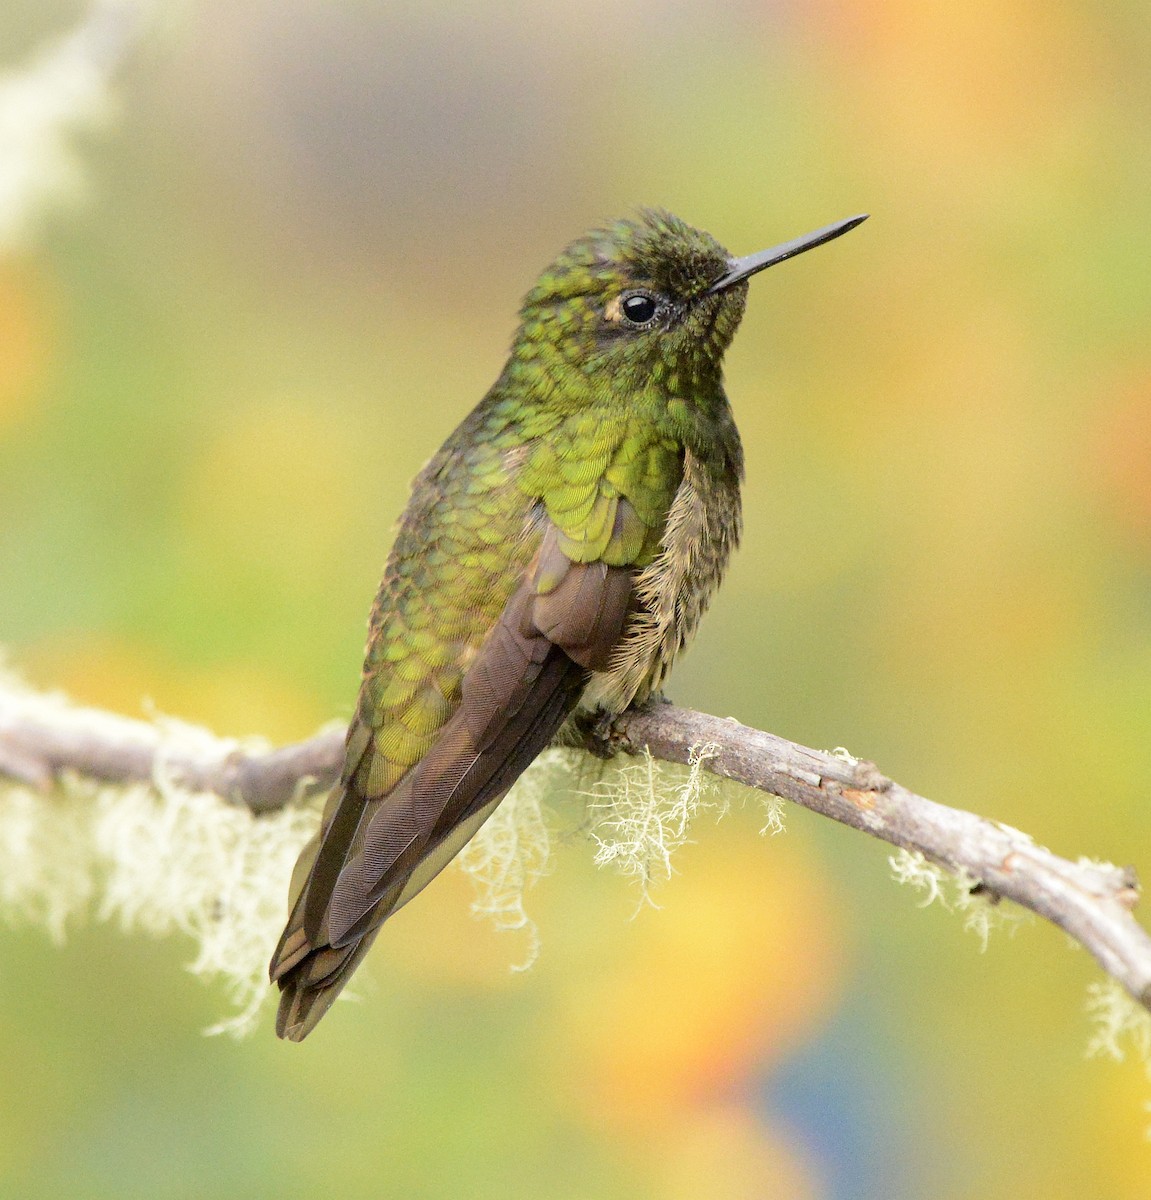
271 511 639 1038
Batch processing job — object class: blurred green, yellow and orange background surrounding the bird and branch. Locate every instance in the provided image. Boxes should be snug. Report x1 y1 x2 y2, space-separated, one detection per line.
0 0 1151 1200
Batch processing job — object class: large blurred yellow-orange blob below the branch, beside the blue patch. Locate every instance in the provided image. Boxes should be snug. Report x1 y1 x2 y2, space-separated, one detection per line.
547 820 846 1130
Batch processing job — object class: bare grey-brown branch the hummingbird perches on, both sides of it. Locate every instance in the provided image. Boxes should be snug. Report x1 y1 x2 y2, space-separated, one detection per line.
0 683 1151 1010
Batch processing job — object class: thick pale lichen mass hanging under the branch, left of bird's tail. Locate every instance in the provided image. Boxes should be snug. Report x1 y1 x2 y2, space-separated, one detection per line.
0 779 318 1033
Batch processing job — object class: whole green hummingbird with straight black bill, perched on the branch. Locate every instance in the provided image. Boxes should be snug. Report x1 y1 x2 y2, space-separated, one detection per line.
270 209 865 1042
